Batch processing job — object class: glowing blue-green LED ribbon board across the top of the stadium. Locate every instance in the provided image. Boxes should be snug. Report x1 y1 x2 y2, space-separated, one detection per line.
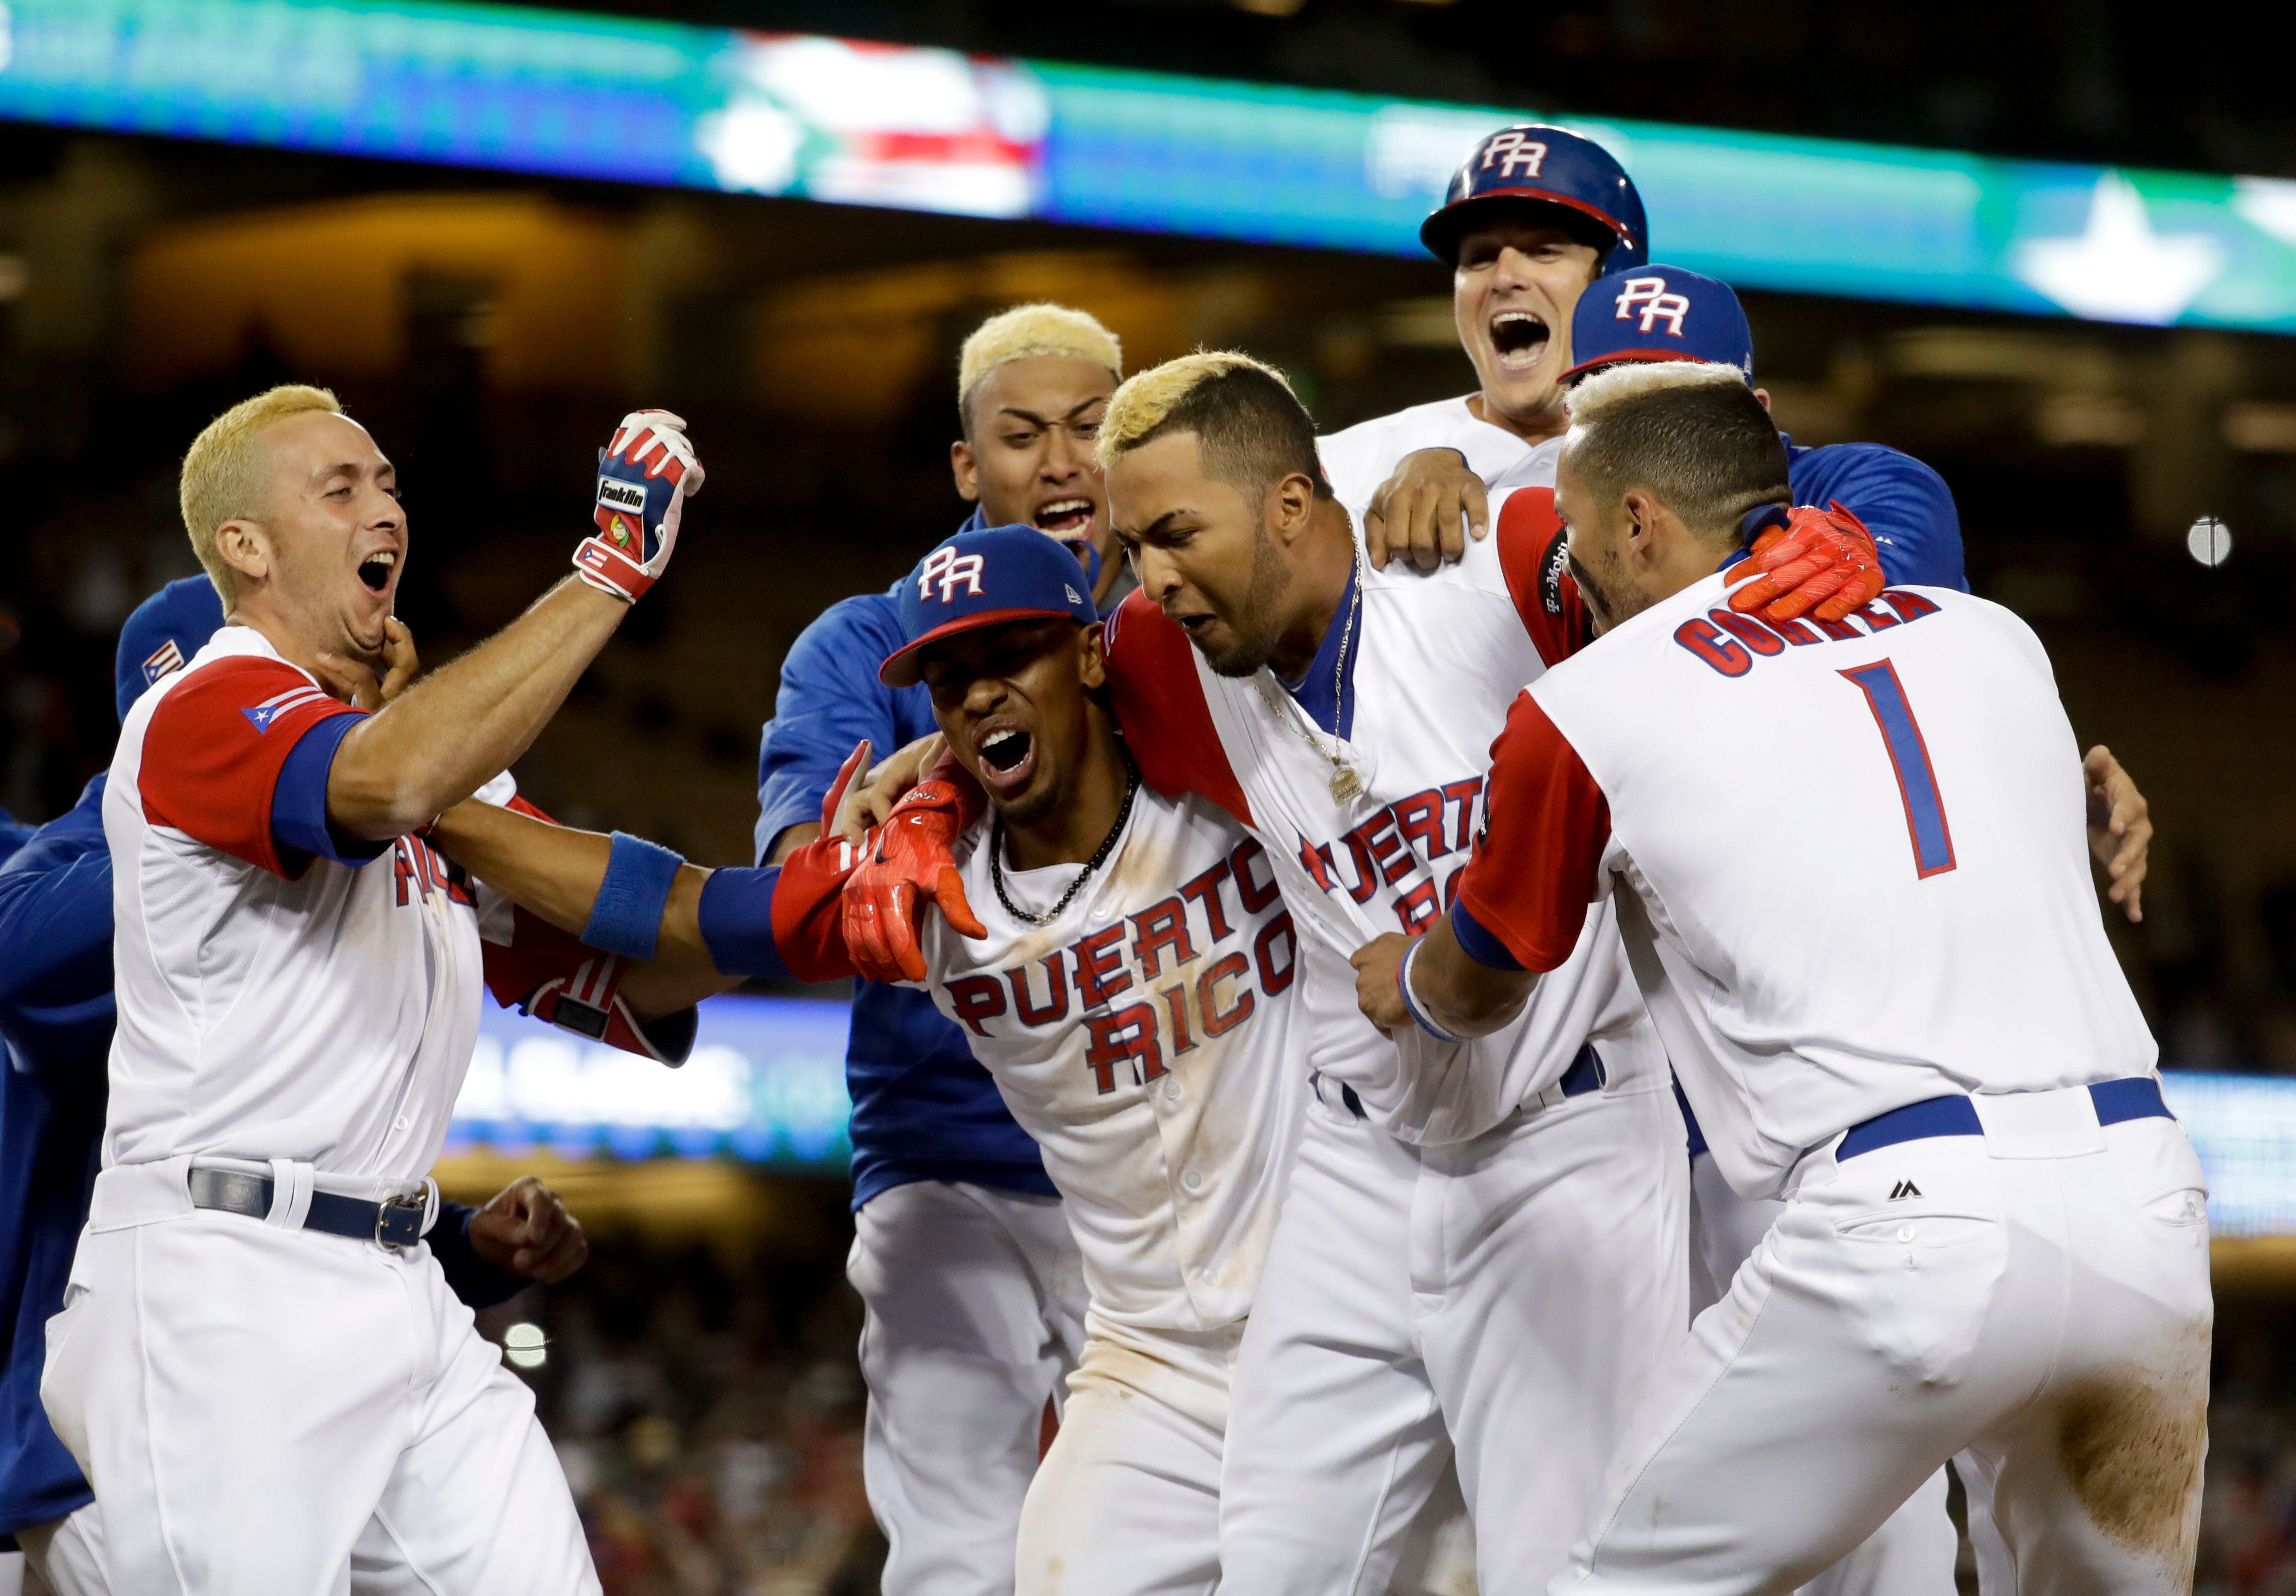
0 0 2296 330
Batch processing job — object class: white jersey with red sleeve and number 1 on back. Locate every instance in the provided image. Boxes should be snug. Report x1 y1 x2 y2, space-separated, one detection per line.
1454 576 2156 1197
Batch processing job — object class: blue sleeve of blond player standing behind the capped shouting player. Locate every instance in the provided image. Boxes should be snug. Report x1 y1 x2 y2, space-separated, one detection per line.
728 593 904 863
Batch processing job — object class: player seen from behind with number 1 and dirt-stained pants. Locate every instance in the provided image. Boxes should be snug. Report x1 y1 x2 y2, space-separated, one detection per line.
1359 363 2214 1593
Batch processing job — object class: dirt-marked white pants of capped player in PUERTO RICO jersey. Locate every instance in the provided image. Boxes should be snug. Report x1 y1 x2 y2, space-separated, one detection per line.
1017 1313 1244 1596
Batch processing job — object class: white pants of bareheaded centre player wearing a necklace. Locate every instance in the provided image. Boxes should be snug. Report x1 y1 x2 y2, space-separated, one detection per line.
1219 1072 1690 1596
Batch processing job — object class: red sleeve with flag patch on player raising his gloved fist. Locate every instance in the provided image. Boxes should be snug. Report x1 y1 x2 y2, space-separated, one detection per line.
135 654 363 877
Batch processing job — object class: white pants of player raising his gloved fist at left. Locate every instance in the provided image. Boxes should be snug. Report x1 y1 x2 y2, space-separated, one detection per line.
41 1157 597 1596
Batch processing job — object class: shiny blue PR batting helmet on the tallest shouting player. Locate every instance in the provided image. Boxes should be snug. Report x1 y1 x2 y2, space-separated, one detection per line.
1419 122 1651 271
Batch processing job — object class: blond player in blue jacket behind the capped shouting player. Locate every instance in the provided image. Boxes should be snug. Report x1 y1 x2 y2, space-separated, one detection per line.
755 305 1123 1596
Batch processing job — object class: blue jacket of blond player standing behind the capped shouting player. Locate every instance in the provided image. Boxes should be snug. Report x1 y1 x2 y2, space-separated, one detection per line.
757 583 1054 1208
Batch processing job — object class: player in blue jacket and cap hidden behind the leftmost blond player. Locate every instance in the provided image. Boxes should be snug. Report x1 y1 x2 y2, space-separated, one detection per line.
0 576 590 1596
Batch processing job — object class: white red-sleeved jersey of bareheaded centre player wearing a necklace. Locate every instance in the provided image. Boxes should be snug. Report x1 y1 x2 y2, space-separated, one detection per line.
1107 489 1662 1144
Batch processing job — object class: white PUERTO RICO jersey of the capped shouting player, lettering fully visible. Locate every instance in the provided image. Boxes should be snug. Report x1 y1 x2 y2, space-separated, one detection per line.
826 785 1306 1332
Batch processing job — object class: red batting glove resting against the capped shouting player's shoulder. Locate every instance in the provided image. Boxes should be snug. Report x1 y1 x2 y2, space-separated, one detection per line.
845 758 990 980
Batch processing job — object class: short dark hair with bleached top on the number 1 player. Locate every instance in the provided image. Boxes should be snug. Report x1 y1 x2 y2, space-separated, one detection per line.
1570 361 1793 542
